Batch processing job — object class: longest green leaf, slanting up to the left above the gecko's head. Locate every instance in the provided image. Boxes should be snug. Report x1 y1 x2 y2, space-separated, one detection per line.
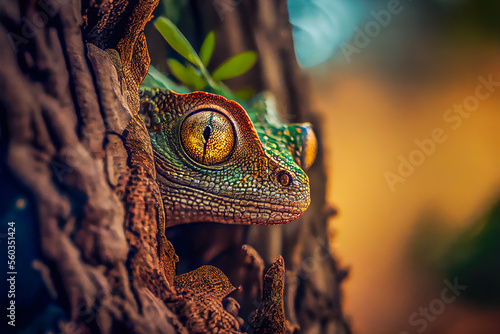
155 17 204 69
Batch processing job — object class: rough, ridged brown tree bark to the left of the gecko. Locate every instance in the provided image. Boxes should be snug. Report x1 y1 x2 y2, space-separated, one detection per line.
0 1 182 333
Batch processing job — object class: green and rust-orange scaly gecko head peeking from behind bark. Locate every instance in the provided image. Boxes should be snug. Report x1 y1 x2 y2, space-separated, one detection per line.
141 90 315 226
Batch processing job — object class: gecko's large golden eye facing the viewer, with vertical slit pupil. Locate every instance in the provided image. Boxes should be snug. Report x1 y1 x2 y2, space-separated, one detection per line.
181 110 235 166
